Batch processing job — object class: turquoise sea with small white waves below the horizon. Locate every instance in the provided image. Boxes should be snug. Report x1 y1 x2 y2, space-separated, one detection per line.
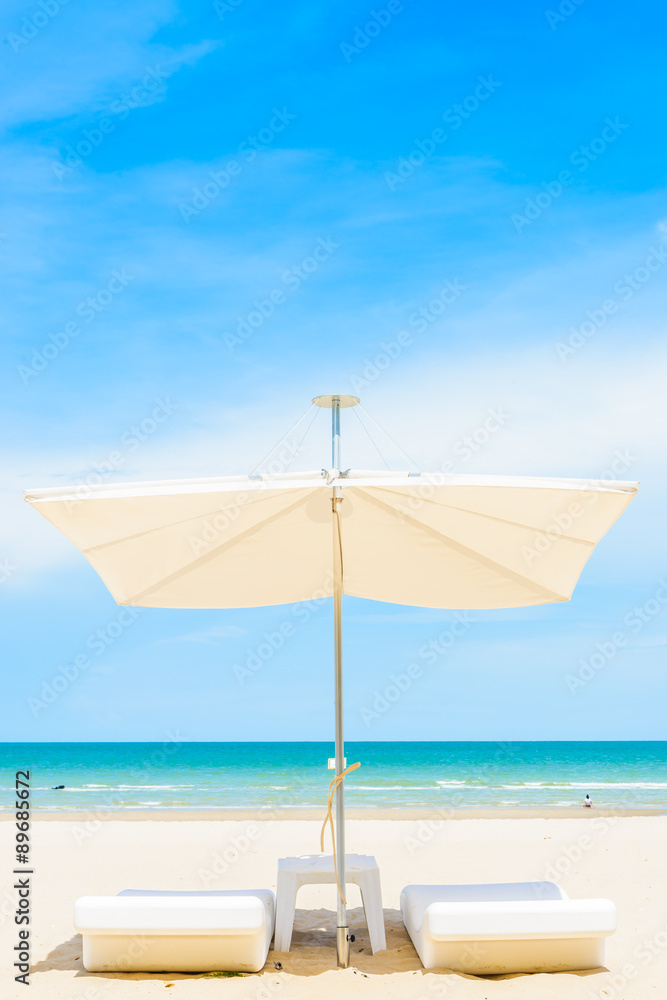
0 736 667 814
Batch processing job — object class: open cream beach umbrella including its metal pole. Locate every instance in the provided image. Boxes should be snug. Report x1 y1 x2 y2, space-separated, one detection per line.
25 395 637 967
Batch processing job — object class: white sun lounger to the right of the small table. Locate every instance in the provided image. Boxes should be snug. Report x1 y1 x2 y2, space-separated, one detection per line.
401 882 616 976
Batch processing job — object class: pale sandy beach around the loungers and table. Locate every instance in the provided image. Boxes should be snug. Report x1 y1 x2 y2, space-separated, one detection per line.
0 811 667 1000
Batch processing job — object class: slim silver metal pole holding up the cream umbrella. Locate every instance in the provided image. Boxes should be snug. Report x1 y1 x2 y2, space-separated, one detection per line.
331 396 350 969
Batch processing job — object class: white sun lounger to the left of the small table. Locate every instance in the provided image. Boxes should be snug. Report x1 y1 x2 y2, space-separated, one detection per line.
74 889 275 972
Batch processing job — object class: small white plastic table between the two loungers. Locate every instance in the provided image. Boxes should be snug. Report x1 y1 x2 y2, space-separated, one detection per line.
273 854 387 954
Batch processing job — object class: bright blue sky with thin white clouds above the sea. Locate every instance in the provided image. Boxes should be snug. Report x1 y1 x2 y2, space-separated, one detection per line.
0 0 667 740
